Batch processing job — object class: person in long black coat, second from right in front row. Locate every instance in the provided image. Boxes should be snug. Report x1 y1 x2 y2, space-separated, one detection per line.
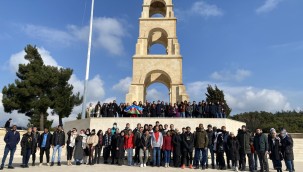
268 131 283 172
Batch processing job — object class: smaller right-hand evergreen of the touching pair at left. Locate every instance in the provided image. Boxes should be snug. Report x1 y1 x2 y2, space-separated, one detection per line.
51 68 82 126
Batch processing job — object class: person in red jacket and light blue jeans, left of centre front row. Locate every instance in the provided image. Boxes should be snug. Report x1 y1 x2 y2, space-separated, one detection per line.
124 130 134 166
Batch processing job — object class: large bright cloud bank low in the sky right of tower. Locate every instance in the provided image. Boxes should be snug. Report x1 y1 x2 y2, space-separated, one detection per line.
187 81 292 114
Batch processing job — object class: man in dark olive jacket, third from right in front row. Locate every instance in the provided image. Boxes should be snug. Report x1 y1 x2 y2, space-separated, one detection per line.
254 128 269 172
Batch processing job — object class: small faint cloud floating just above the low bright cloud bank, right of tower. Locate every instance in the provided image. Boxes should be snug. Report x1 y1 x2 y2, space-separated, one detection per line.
210 69 251 81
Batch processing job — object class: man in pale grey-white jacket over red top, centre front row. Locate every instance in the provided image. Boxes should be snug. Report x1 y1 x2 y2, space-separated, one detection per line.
151 126 163 167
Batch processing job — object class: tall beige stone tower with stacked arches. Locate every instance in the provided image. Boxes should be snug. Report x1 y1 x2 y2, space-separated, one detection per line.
126 0 189 103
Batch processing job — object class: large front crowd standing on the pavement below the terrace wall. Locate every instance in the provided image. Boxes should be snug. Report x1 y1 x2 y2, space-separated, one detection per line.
0 121 295 172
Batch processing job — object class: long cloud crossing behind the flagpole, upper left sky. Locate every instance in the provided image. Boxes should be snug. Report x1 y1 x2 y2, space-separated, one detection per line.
23 17 128 55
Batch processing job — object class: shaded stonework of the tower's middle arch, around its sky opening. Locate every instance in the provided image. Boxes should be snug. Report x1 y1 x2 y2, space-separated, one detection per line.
147 28 168 54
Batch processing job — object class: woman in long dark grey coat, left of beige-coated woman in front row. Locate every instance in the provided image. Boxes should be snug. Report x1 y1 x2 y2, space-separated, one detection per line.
74 130 87 165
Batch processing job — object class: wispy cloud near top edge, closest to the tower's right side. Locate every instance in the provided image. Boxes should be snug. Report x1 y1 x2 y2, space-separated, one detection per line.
190 1 223 18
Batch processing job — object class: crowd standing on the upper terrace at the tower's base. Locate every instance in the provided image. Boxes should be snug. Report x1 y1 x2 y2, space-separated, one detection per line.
86 100 226 118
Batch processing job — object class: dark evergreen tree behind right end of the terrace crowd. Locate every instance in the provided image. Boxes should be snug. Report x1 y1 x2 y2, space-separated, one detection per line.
205 85 232 117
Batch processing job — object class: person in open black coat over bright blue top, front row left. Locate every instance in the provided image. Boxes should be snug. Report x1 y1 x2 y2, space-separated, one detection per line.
38 128 52 166
